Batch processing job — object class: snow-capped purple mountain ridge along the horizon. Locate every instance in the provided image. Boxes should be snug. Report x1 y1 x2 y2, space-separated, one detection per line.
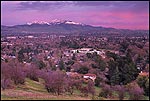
1 19 148 34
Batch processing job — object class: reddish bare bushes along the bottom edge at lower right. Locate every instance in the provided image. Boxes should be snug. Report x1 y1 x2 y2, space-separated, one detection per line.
99 82 144 100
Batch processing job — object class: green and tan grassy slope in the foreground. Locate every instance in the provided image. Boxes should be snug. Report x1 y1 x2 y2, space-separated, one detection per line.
1 79 149 100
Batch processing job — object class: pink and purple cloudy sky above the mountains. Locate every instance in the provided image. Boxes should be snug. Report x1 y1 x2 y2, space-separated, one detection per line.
1 1 149 30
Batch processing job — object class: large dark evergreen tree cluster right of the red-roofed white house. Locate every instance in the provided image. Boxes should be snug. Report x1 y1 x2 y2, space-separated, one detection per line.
108 52 138 85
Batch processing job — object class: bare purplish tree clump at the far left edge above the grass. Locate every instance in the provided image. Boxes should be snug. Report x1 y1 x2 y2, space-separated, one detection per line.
1 62 26 89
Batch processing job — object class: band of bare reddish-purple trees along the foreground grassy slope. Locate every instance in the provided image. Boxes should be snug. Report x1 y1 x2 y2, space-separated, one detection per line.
1 58 149 100
